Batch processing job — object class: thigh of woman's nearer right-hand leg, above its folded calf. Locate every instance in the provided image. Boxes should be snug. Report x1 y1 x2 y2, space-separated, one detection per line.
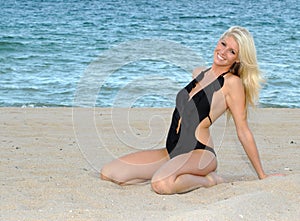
152 150 217 182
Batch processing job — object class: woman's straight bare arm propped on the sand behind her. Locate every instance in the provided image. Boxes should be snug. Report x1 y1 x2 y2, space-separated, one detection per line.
226 76 267 179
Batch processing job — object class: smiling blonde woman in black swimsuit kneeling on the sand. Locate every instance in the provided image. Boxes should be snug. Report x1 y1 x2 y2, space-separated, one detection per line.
101 27 282 194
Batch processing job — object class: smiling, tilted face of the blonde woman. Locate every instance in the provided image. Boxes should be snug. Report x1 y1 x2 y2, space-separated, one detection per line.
214 36 239 68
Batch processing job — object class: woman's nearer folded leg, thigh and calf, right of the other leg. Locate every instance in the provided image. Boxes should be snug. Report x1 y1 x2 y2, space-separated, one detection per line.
151 150 222 194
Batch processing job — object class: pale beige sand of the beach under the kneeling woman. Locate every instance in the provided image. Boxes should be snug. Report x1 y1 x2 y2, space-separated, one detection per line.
0 108 300 221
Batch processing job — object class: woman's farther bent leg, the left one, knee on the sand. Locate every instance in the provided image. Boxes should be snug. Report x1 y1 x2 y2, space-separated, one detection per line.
101 149 169 185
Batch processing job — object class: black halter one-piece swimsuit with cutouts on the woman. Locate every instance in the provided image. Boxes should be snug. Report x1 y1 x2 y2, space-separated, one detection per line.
166 69 228 158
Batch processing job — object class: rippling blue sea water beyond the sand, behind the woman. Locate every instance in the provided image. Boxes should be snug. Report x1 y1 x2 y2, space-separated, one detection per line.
0 0 300 108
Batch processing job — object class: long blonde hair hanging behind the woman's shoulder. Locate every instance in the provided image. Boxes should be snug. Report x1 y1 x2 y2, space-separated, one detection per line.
221 26 263 107
